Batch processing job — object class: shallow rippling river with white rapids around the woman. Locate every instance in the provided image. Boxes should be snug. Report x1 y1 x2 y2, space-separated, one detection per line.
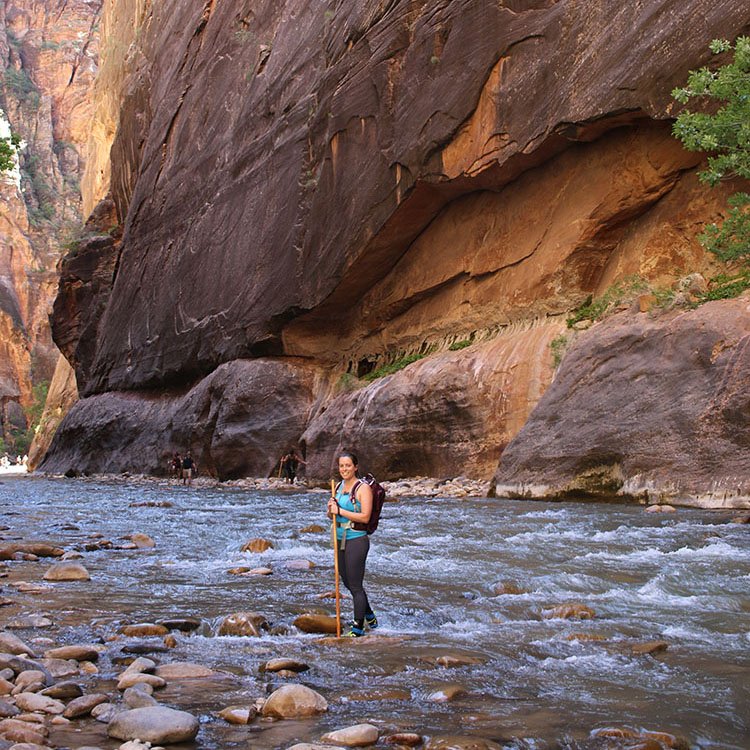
0 478 750 750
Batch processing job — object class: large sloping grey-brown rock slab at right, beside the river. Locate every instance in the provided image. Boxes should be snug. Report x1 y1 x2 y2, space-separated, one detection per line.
495 294 750 506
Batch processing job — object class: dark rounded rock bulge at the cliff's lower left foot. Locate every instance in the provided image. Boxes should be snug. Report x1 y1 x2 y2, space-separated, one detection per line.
41 359 320 479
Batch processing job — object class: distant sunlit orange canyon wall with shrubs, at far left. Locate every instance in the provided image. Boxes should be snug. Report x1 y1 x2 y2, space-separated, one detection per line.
0 0 102 452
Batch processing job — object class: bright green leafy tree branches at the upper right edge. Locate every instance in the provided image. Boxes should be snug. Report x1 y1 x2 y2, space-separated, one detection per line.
672 37 750 261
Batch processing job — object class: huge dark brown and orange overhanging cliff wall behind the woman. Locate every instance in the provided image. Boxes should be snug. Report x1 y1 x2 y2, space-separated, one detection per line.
39 0 750 506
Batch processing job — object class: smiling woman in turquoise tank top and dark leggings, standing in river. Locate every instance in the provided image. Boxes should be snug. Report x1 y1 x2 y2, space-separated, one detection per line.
328 451 378 638
